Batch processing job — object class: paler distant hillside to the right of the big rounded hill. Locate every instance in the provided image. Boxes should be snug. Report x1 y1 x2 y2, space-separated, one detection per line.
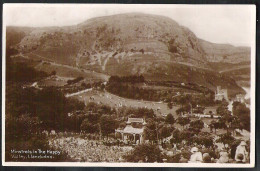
200 40 251 87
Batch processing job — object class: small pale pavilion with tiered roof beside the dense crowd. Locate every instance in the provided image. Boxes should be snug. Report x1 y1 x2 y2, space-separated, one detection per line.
115 118 146 144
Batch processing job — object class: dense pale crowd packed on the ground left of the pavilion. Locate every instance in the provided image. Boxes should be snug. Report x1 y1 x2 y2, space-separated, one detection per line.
49 136 132 162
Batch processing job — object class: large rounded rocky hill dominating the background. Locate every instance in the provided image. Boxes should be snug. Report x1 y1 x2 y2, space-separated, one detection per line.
7 13 247 97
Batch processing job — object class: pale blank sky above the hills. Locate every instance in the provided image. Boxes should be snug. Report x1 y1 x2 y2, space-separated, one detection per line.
4 4 255 46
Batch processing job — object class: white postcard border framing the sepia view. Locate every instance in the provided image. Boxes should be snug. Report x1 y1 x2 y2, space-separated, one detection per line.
2 3 256 168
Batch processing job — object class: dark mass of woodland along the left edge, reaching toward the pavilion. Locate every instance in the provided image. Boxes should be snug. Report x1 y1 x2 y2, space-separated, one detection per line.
5 49 157 162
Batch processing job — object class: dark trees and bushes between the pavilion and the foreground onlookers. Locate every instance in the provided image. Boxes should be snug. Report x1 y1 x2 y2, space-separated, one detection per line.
124 111 246 163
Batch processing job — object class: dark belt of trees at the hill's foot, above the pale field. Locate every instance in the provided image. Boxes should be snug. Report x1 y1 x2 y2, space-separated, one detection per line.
106 75 214 103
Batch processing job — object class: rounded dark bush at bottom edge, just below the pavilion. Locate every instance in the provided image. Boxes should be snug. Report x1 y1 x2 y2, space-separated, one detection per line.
123 144 162 163
